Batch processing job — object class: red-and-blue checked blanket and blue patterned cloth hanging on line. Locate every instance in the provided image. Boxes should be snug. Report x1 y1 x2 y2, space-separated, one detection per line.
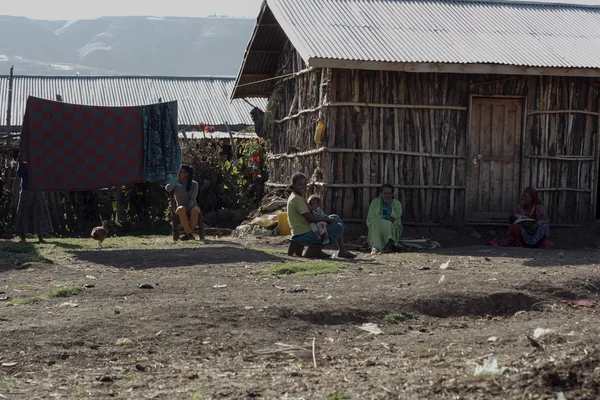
21 96 181 191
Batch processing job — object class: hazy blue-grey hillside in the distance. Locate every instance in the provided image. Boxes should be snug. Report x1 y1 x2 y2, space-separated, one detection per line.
0 16 254 76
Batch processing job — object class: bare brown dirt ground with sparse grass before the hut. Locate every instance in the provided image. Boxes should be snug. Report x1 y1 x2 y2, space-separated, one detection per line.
0 237 600 400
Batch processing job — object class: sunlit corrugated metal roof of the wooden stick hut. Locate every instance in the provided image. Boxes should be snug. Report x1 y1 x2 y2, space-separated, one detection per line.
267 0 600 68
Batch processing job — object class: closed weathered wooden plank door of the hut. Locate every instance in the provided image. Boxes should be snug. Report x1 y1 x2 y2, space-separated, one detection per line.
466 97 523 222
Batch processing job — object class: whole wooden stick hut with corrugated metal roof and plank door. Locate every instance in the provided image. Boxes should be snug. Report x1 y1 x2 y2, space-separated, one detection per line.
232 0 600 225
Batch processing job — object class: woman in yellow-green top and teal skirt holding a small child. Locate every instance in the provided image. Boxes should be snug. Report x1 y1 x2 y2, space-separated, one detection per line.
287 172 356 258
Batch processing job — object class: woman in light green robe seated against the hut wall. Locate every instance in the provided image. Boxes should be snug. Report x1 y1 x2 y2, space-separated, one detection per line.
367 183 402 254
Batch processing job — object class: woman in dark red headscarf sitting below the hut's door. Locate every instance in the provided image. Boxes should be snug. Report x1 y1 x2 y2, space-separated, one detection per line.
489 187 550 249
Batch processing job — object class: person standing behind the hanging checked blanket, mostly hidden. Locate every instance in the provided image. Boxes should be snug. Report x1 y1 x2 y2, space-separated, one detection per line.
15 161 53 243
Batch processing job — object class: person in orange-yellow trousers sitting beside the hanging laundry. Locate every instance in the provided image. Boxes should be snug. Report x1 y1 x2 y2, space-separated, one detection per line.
165 164 200 240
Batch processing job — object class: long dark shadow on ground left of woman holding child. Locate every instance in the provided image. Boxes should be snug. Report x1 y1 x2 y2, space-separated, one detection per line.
70 246 285 269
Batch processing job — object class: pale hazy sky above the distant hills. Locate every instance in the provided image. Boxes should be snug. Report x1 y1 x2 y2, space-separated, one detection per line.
0 0 600 20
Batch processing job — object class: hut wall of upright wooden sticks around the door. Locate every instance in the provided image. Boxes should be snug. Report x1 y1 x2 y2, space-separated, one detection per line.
268 49 600 224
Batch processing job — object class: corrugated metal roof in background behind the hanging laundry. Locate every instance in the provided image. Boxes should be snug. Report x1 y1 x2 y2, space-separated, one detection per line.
0 76 266 126
